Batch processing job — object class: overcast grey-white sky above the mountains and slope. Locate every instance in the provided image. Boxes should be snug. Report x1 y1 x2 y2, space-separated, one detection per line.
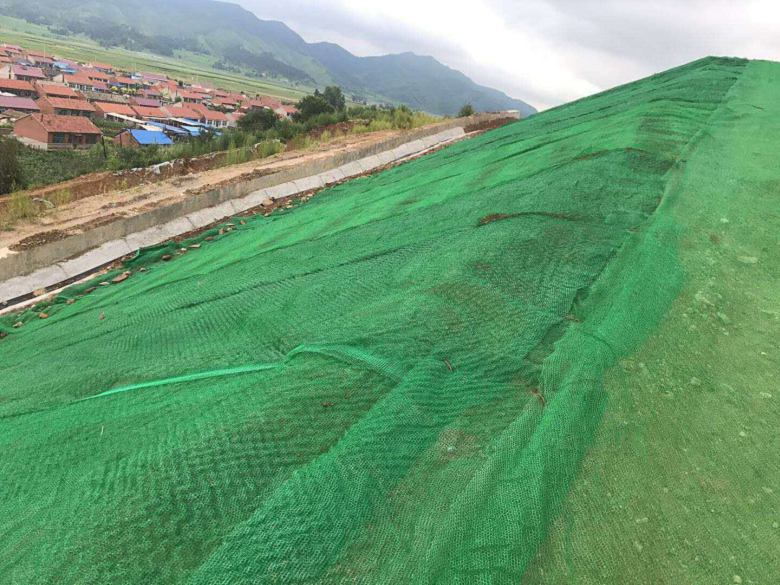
238 0 780 109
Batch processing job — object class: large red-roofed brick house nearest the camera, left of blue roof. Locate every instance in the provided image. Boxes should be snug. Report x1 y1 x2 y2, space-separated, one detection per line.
14 114 101 150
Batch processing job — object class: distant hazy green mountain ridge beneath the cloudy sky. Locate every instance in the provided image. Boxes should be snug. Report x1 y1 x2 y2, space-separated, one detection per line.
0 0 536 116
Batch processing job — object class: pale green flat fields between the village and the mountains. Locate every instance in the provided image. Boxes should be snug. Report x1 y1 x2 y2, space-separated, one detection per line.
0 15 312 101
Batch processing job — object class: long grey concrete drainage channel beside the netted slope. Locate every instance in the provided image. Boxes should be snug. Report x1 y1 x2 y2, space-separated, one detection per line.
0 123 478 310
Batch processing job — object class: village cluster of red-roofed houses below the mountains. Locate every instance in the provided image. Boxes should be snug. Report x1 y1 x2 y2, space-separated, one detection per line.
0 44 296 150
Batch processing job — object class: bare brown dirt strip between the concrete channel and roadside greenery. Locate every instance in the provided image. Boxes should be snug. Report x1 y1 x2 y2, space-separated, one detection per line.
0 130 402 258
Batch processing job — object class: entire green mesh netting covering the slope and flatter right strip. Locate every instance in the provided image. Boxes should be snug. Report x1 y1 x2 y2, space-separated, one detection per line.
0 58 780 585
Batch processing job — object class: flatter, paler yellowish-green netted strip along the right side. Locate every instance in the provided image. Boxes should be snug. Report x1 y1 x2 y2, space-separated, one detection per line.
526 61 780 585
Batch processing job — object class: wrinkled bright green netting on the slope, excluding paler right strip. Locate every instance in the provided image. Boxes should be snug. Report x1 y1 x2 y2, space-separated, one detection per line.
0 59 760 583
